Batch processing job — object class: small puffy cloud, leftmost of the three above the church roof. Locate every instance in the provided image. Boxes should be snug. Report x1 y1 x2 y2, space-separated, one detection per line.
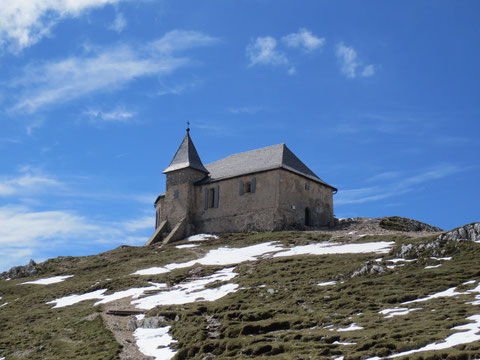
247 36 288 66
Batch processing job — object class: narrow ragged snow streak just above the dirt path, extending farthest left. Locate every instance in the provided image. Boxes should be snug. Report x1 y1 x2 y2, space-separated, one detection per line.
47 283 167 308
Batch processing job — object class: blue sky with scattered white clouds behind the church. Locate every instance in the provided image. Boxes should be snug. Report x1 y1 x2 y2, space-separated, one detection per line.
0 0 480 270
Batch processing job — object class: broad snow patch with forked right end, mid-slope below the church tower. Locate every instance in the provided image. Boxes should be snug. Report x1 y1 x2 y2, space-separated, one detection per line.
132 268 238 310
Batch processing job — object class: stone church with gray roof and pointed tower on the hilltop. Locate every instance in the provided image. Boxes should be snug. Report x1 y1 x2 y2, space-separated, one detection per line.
147 129 337 244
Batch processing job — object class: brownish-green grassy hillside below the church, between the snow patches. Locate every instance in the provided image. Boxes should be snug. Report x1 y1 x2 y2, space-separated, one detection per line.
0 226 480 360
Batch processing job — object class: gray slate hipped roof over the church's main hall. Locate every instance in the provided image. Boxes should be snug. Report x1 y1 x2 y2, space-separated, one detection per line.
200 144 337 191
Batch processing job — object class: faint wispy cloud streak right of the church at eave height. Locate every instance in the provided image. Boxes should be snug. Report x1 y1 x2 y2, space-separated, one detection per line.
335 164 468 205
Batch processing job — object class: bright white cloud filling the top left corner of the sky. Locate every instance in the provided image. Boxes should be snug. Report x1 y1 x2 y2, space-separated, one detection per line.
0 0 123 50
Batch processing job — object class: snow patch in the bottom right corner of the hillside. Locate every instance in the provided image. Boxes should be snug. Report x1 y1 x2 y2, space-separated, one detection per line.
390 315 480 358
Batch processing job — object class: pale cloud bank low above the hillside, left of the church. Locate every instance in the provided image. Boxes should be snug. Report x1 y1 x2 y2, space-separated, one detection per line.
0 206 154 271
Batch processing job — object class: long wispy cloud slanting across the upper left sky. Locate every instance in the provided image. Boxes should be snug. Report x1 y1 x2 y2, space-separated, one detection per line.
10 30 219 113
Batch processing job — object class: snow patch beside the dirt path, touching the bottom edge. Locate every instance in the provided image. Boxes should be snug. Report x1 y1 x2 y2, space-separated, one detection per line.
133 326 177 360
